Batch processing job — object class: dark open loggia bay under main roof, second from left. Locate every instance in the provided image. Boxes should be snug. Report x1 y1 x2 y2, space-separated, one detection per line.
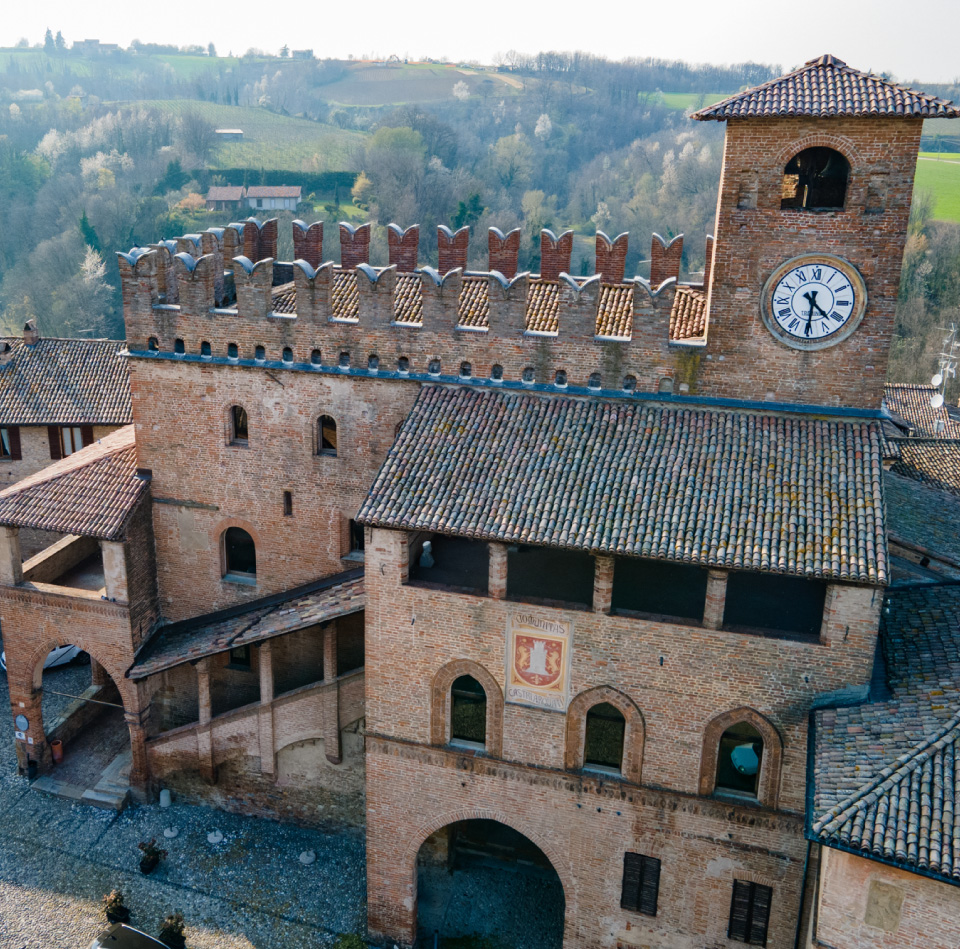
507 545 593 607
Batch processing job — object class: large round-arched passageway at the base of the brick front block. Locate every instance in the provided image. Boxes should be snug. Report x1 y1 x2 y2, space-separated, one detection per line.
417 819 565 949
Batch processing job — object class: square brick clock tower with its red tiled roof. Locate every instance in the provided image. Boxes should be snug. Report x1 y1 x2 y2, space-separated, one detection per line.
694 56 960 409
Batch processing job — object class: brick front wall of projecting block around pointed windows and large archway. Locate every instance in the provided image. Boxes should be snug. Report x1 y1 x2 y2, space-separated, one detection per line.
366 530 881 947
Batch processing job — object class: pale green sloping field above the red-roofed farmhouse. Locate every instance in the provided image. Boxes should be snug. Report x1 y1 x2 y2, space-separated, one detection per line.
136 99 365 172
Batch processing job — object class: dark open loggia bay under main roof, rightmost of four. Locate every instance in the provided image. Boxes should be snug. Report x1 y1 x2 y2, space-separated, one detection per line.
723 572 827 639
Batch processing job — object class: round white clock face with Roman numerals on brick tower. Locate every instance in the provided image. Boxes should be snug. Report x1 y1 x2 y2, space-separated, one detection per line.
760 254 867 350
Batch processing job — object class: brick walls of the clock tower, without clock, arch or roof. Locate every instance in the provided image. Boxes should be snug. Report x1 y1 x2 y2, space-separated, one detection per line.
698 118 922 409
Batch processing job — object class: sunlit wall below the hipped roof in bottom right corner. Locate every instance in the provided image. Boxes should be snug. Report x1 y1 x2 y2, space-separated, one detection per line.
808 847 960 949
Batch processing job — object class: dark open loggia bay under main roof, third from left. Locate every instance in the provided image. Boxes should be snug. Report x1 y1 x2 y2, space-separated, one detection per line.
611 557 707 623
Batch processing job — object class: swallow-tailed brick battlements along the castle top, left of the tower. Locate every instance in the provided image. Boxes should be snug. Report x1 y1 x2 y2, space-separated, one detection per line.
118 219 706 391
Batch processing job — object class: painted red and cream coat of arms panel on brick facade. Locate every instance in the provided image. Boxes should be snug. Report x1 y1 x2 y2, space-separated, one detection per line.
507 612 573 712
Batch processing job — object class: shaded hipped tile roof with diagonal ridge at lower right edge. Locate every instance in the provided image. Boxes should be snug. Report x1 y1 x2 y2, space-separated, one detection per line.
809 585 960 882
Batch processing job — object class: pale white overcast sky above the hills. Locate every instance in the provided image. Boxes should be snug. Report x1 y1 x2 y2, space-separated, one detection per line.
0 0 960 82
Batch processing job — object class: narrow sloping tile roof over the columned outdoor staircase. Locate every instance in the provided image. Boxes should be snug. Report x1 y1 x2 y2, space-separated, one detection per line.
127 567 365 679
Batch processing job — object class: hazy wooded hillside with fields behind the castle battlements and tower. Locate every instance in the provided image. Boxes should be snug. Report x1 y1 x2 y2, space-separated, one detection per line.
0 43 960 392
